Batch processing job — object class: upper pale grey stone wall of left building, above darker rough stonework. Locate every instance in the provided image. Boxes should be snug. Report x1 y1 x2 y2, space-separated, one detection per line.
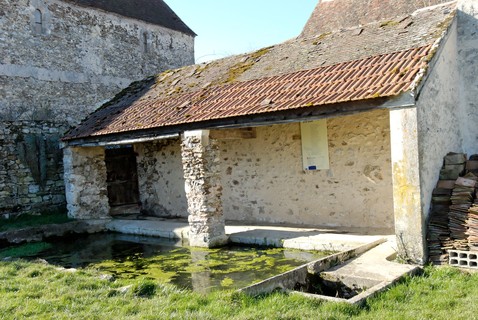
0 0 194 124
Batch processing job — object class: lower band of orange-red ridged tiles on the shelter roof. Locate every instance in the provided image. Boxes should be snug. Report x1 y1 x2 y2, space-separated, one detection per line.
62 45 431 139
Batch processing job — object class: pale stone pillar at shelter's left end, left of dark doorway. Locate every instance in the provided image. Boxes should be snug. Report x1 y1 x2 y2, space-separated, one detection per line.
63 147 111 219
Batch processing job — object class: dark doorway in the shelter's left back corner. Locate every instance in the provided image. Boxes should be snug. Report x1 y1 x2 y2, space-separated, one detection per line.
105 146 141 216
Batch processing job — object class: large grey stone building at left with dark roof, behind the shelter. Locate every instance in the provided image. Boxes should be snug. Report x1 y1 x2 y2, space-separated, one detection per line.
0 0 195 216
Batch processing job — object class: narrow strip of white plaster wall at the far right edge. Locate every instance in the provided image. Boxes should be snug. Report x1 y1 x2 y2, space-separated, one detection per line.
457 0 478 155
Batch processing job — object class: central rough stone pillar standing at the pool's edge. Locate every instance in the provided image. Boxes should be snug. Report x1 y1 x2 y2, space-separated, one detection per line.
182 130 228 248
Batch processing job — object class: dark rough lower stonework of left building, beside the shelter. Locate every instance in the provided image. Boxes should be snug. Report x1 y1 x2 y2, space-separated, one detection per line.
0 121 65 217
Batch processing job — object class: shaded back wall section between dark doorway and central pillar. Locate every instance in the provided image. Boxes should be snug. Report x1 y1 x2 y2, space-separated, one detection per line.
134 139 188 218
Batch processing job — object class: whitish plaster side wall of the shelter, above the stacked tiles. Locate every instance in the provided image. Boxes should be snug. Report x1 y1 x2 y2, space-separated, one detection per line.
416 24 462 219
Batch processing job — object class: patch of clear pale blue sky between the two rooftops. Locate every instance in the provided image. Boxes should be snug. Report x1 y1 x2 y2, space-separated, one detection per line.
165 0 318 63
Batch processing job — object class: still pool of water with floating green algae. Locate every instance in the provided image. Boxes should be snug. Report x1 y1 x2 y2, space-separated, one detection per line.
0 234 328 293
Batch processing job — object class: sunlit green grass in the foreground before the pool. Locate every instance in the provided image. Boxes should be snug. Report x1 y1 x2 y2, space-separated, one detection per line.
0 261 478 319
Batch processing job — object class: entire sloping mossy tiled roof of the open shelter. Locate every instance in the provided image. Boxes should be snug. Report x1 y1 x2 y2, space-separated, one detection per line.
64 3 456 140
